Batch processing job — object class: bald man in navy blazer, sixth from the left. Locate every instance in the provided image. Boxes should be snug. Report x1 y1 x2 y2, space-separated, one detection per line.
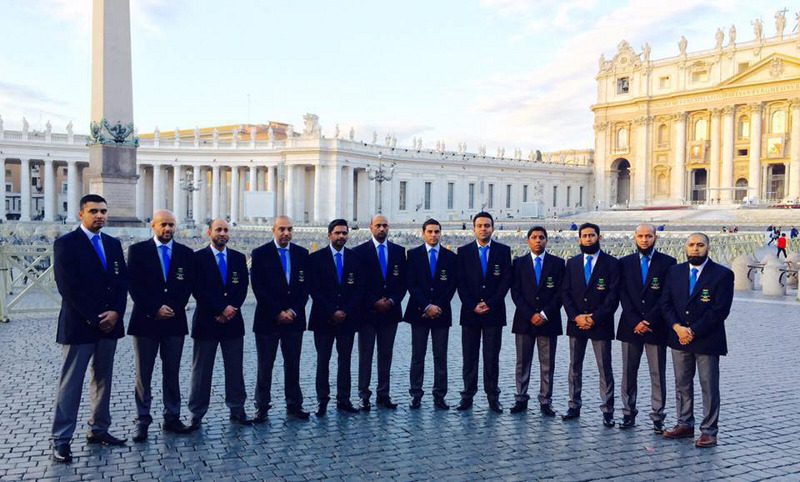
353 214 406 411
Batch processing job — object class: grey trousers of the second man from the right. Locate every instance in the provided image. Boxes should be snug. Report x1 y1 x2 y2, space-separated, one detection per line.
620 342 667 422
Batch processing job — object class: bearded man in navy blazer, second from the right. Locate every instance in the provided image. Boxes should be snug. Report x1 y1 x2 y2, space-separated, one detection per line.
617 224 676 433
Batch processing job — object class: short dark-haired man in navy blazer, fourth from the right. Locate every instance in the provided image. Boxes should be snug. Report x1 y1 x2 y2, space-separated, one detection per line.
511 226 564 417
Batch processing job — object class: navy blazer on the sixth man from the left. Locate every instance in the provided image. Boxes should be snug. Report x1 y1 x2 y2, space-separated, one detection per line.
353 239 406 324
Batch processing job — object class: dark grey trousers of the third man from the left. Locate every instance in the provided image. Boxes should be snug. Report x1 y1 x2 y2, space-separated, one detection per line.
189 337 247 421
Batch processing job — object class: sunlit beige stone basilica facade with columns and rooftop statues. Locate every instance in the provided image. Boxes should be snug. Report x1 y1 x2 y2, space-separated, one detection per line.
592 12 800 208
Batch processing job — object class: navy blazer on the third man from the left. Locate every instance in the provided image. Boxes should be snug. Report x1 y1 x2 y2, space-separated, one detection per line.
192 246 249 341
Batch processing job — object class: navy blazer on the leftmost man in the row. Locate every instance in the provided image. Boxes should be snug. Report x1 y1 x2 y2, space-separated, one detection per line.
53 227 128 345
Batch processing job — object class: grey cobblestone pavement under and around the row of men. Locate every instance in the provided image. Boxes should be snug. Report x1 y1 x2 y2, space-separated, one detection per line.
0 297 800 481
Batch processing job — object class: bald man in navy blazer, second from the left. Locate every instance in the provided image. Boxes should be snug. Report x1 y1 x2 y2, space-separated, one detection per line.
128 210 194 442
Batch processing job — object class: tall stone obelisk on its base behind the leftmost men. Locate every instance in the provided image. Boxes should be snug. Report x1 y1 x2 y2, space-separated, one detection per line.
86 0 140 225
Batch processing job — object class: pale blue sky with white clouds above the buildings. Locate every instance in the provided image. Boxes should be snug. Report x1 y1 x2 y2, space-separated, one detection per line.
0 0 795 153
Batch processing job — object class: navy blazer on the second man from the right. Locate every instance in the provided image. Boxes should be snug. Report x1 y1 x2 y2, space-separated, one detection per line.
617 251 677 345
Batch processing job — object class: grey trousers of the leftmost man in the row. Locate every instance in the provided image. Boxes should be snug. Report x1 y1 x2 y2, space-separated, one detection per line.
52 338 117 445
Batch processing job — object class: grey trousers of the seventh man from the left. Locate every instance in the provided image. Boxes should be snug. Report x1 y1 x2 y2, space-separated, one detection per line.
408 324 450 398
